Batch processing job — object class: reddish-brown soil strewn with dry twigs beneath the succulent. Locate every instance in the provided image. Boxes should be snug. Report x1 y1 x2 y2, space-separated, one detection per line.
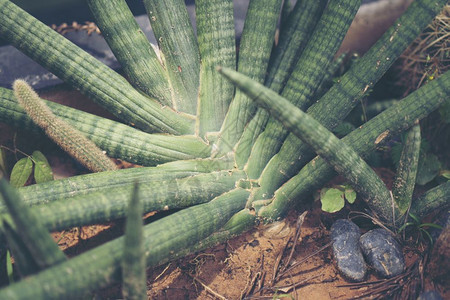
54 198 450 299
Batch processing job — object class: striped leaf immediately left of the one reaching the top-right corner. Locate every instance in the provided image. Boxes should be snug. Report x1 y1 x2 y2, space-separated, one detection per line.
246 0 361 179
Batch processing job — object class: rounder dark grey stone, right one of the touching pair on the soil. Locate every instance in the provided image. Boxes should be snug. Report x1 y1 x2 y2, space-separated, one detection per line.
359 228 405 278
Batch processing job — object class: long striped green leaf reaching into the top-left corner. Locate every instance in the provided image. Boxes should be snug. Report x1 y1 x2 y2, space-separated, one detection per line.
0 0 195 134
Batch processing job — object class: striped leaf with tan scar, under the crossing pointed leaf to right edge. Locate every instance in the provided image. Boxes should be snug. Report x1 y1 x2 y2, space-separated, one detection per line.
254 72 450 220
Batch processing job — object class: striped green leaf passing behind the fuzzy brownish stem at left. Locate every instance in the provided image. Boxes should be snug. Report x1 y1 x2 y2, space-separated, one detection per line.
0 88 211 166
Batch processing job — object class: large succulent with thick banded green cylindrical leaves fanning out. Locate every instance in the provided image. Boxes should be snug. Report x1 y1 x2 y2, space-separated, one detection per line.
0 0 450 299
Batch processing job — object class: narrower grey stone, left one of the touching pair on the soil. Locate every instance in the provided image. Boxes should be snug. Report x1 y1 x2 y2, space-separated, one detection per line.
331 219 367 281
